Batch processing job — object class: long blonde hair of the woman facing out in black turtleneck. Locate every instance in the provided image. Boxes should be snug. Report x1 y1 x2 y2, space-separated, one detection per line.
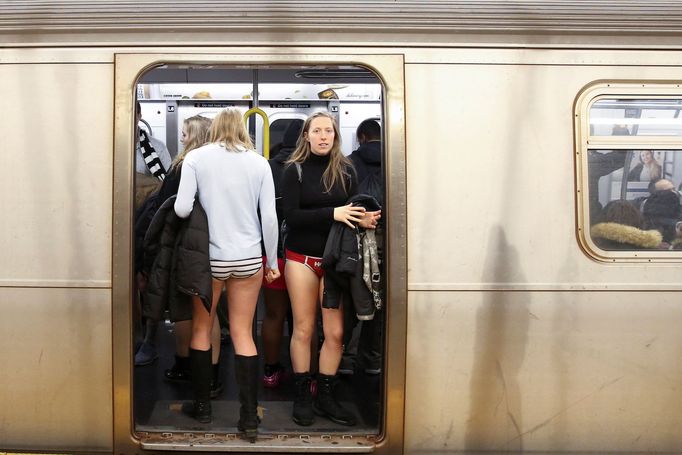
286 111 353 194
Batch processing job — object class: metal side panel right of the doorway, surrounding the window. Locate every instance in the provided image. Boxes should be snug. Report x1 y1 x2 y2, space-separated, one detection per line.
405 50 682 452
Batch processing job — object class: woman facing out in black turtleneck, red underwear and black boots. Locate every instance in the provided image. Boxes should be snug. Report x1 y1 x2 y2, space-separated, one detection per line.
282 112 379 426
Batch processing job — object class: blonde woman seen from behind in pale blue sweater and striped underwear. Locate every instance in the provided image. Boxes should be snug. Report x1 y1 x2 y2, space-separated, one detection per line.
175 109 280 440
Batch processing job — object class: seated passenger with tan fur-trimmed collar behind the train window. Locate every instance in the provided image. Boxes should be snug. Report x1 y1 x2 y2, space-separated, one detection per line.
590 199 663 250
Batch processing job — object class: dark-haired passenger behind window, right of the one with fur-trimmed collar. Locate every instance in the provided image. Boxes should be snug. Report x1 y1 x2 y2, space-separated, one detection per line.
642 187 680 249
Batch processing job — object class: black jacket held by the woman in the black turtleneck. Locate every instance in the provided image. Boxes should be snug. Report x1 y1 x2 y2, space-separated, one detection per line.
322 194 381 320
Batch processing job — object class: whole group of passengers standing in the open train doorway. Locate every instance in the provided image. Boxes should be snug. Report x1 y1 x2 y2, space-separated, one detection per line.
135 104 383 441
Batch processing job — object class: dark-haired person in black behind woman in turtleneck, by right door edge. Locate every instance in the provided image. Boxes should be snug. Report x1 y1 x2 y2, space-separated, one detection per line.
339 119 384 375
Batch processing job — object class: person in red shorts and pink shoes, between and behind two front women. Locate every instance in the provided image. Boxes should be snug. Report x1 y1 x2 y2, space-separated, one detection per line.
261 119 303 388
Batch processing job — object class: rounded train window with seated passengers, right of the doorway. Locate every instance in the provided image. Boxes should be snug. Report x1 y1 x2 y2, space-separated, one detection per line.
577 87 682 260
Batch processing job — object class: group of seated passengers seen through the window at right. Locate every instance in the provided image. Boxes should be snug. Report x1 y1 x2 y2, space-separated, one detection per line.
590 178 682 250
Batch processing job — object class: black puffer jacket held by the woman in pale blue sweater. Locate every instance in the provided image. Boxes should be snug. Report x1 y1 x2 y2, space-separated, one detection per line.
142 196 212 321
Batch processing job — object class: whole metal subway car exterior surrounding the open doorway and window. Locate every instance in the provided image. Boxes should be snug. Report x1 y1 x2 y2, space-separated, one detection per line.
0 2 682 454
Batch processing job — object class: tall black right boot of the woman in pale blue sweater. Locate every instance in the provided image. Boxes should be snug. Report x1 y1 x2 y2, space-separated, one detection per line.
234 354 260 442
